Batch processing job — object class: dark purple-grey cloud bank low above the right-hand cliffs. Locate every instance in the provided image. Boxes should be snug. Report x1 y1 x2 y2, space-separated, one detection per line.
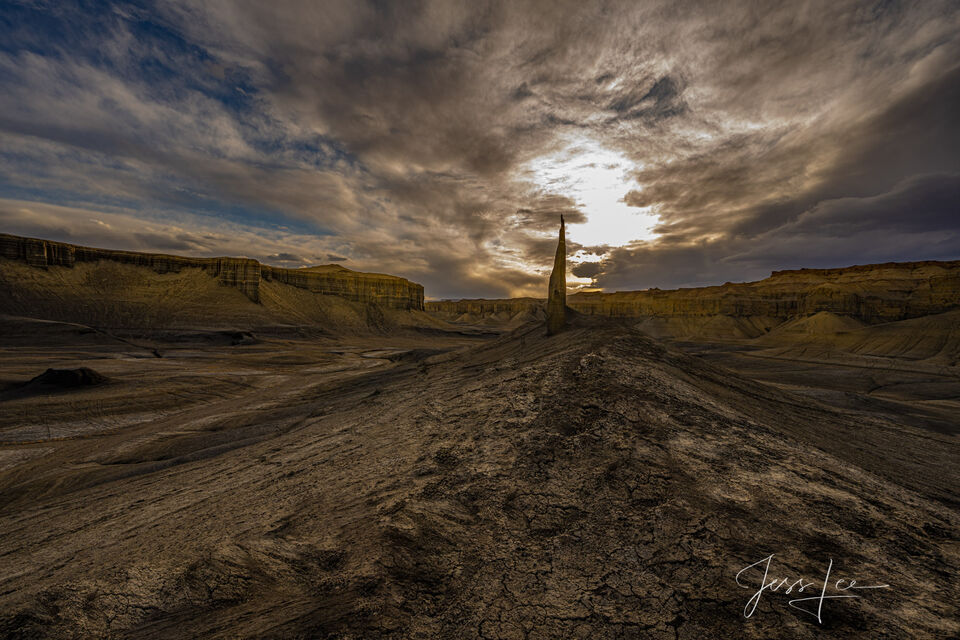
592 174 960 289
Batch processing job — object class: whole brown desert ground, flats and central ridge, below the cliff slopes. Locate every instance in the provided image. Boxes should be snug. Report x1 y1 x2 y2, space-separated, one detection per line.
0 306 960 638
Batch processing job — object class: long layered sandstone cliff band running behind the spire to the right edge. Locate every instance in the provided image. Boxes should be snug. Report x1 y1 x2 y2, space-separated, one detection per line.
426 261 960 324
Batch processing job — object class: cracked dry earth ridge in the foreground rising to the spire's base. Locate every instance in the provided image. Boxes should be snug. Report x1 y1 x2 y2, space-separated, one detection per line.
0 319 960 640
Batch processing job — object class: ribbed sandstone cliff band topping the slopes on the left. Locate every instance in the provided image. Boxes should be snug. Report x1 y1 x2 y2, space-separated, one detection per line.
0 234 423 310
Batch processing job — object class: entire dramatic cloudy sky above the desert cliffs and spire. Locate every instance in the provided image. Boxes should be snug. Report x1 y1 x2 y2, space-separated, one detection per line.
0 0 960 298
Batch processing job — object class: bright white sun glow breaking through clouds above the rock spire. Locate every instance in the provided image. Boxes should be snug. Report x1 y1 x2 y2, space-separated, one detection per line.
526 138 658 247
